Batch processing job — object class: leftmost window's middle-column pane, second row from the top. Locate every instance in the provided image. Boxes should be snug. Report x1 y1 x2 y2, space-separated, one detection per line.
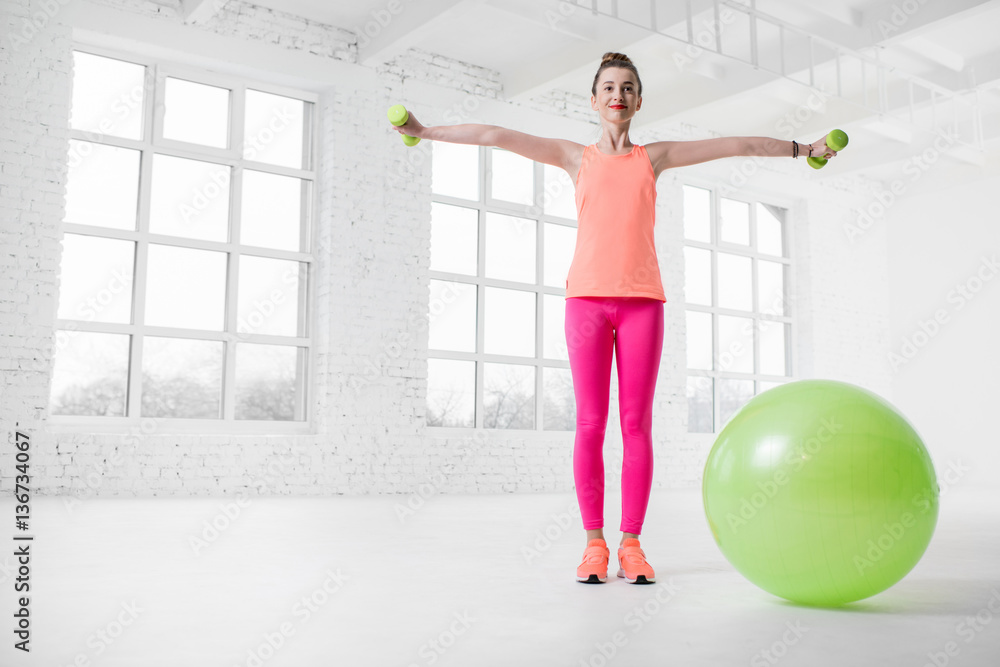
149 155 230 241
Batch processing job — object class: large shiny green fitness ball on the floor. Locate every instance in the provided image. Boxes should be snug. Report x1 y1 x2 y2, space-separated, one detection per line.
702 380 938 606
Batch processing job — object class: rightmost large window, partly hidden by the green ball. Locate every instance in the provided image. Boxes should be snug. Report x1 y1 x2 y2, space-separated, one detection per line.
683 185 792 433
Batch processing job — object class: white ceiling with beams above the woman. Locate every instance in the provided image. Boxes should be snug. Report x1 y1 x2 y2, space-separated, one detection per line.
242 0 1000 187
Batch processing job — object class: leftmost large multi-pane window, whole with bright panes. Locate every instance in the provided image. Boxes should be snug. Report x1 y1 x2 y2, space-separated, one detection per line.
50 47 316 425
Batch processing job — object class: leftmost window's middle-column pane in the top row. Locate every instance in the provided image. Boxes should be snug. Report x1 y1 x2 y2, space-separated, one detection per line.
163 77 229 148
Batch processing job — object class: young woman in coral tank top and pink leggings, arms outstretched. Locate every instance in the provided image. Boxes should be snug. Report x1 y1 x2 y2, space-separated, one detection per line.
395 53 837 583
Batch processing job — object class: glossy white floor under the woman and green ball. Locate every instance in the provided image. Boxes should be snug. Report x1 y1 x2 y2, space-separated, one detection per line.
0 488 1000 667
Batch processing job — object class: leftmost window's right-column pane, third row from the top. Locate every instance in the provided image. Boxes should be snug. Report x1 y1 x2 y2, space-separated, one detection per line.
236 255 307 336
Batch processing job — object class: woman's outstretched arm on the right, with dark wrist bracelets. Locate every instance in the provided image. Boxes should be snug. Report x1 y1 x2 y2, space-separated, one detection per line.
646 136 837 174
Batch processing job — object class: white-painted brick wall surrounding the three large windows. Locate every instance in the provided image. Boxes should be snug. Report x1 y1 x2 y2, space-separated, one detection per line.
0 0 888 497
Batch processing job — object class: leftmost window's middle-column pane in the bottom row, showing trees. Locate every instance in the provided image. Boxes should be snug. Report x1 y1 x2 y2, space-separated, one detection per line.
142 336 222 419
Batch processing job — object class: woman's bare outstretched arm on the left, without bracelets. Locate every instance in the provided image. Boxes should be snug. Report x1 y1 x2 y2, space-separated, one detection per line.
393 112 583 171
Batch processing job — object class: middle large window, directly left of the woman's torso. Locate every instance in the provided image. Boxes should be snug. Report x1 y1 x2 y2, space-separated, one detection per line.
427 142 576 431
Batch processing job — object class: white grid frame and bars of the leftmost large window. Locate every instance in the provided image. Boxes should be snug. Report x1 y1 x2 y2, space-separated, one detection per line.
49 41 320 435
